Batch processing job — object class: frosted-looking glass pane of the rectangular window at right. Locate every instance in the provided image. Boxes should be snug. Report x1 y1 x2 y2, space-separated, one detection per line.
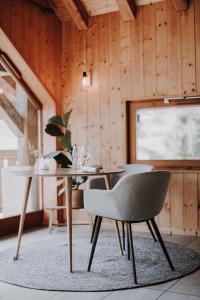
136 106 200 160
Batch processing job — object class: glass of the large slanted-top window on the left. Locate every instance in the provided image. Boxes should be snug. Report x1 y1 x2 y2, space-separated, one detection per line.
0 60 40 218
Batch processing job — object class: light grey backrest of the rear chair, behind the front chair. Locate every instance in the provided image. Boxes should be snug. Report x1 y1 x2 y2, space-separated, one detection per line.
111 164 154 187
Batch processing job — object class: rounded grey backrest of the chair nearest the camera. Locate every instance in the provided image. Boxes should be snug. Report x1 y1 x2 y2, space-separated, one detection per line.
112 171 171 221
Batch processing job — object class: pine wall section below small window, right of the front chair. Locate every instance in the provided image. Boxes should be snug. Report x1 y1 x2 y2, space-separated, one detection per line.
158 171 200 235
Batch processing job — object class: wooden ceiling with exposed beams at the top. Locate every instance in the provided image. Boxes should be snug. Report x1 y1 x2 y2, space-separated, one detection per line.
31 0 190 30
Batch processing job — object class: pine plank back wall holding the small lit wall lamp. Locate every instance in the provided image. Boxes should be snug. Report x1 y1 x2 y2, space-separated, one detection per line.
62 0 200 166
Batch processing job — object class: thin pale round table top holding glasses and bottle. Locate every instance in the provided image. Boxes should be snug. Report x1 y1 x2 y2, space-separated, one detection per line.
12 167 124 177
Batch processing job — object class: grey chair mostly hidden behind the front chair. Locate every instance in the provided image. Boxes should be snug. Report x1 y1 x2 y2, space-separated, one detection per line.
88 164 156 248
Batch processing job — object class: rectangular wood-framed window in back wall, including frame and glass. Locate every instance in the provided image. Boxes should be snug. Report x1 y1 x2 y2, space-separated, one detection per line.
129 100 200 167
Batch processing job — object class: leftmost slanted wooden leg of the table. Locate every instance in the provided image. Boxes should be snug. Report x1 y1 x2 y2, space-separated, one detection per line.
14 177 32 260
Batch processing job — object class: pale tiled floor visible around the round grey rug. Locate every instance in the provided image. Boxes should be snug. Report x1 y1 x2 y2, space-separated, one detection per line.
0 226 200 300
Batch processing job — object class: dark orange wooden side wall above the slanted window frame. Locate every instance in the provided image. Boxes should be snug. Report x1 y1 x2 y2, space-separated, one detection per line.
0 0 62 108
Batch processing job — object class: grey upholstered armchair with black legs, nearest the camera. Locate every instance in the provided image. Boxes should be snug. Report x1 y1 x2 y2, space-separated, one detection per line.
84 171 174 283
